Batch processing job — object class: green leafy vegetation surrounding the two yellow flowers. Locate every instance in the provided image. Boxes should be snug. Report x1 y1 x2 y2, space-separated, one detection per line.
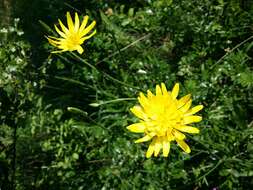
0 0 253 190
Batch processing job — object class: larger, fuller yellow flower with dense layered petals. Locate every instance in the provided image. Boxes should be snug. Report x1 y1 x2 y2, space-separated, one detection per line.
127 83 203 158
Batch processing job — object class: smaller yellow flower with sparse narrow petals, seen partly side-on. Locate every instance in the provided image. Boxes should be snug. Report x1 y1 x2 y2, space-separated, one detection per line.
47 12 96 54
